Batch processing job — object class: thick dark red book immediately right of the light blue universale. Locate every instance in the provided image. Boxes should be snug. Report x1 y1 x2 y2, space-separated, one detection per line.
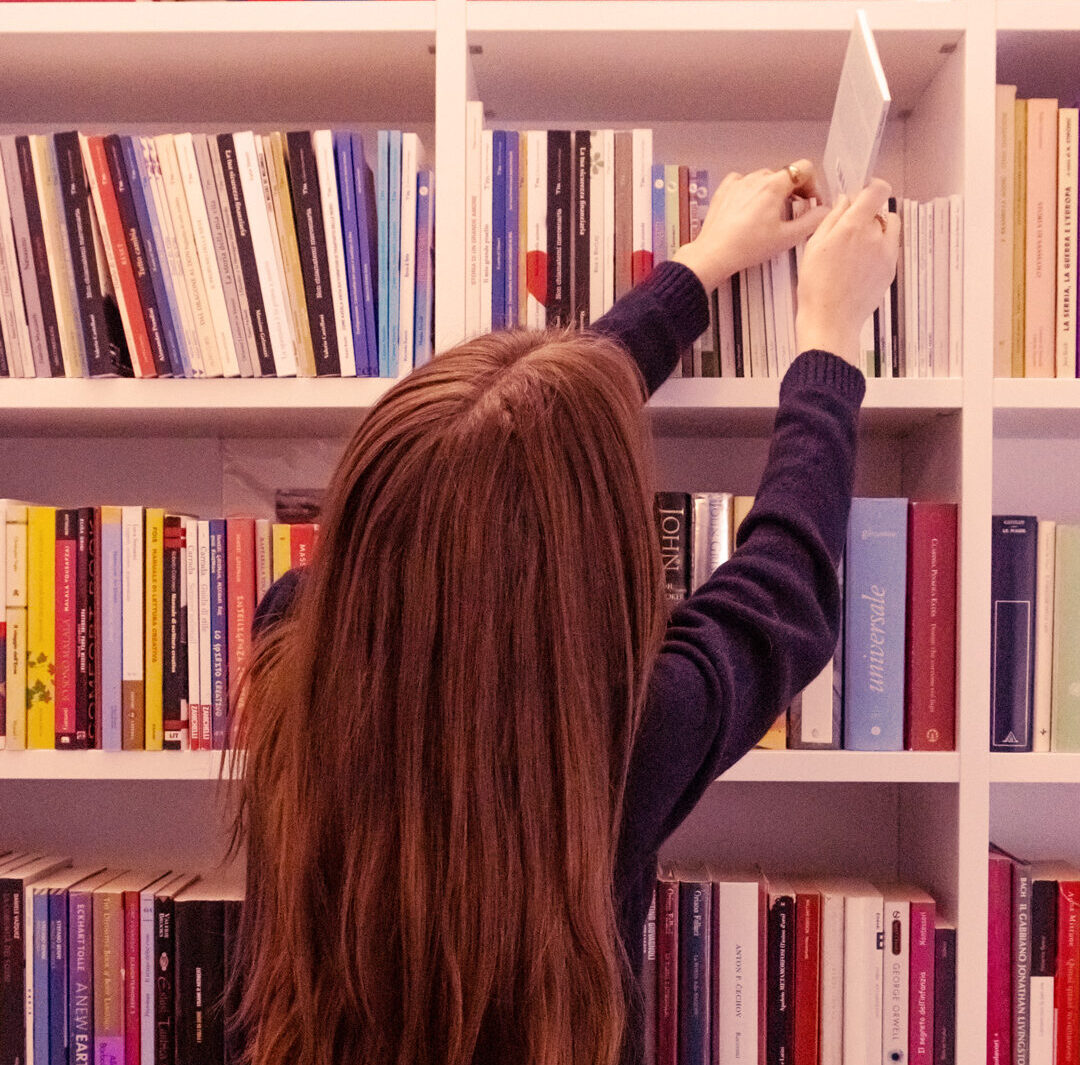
904 502 957 751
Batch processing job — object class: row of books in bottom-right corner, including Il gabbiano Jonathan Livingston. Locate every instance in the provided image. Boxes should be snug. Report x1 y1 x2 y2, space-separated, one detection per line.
986 845 1080 1065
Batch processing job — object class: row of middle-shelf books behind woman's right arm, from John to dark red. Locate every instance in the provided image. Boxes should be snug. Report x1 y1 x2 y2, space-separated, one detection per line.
656 493 957 751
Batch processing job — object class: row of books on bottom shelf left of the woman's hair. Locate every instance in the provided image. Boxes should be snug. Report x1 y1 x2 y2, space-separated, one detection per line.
0 847 242 1065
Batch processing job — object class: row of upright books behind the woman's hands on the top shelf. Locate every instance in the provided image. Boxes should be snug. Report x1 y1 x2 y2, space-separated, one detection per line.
465 104 962 377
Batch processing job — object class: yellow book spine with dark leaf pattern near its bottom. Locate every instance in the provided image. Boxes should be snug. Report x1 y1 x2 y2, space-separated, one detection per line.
26 507 56 749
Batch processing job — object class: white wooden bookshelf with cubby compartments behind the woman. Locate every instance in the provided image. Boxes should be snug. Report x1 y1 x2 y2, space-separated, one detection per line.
0 0 1080 1065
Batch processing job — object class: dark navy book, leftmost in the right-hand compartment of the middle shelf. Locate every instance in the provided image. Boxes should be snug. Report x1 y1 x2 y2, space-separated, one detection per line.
990 514 1039 751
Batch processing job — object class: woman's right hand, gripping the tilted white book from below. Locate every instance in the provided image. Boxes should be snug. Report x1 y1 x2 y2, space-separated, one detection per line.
795 178 900 365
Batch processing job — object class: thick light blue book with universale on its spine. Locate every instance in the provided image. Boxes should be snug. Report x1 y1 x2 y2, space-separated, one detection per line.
843 499 907 751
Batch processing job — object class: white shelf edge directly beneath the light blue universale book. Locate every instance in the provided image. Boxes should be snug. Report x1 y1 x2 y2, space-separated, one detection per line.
719 751 960 783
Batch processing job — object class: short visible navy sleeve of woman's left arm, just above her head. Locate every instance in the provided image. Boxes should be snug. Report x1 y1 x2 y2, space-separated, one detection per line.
590 261 708 395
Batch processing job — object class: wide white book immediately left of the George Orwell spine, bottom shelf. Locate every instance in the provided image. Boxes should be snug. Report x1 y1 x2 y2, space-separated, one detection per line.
843 895 883 1065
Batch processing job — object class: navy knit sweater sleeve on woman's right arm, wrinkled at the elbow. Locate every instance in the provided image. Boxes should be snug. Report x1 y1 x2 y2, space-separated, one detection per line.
621 351 865 862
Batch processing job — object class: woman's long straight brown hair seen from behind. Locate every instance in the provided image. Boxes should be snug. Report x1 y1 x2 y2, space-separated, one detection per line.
234 332 664 1065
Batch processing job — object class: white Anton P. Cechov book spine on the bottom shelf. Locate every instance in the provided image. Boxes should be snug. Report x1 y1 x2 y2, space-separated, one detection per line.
714 880 765 1065
